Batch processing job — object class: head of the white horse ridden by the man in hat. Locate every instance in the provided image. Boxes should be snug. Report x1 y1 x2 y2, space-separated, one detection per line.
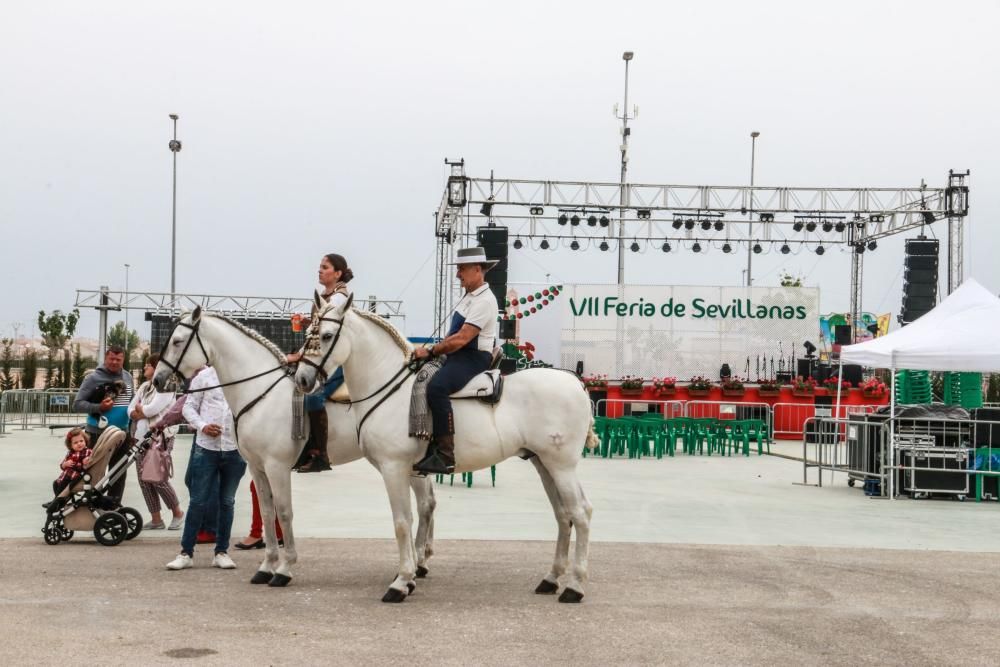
295 292 354 392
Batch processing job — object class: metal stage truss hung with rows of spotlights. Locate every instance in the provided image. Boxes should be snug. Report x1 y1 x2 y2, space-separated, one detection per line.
434 160 969 339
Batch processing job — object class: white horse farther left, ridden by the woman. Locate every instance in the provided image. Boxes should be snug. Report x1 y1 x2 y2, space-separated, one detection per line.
153 307 435 586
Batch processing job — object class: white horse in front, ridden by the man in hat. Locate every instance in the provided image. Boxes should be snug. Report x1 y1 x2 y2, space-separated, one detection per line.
295 294 597 602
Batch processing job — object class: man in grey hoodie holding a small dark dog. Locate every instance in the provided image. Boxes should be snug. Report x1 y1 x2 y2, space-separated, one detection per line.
73 345 134 504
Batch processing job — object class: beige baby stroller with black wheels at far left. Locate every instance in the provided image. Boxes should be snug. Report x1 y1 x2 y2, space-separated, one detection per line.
42 426 152 547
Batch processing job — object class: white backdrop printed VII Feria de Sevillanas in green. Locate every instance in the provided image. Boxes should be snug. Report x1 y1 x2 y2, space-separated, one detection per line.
508 285 819 381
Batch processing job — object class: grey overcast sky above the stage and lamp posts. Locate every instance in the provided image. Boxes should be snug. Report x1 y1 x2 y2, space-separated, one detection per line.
0 0 1000 337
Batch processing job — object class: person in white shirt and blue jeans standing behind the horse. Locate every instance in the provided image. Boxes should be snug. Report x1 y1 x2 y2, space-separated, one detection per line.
167 366 247 570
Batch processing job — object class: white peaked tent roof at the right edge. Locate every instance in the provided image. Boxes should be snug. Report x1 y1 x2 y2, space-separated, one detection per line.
840 278 1000 373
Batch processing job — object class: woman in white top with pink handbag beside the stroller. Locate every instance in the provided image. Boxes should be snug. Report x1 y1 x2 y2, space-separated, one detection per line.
128 354 184 530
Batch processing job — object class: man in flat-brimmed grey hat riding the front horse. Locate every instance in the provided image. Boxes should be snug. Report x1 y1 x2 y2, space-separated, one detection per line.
413 247 498 474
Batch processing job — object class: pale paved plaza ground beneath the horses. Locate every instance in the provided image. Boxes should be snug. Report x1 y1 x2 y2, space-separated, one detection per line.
0 429 1000 665
